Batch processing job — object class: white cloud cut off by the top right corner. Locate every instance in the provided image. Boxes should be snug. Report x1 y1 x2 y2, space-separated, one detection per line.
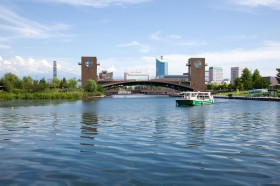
232 0 280 10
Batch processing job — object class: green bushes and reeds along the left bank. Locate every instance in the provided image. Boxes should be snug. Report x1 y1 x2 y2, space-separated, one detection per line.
0 73 104 100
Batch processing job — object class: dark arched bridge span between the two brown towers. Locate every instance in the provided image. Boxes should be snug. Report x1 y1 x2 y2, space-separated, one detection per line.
98 80 194 91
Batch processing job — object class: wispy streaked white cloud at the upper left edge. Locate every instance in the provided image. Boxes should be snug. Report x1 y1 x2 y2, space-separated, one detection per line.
0 6 72 39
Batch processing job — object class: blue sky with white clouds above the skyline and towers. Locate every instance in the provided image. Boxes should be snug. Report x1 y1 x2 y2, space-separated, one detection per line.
0 0 280 79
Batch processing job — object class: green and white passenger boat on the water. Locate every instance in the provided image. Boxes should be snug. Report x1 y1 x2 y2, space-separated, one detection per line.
176 92 214 106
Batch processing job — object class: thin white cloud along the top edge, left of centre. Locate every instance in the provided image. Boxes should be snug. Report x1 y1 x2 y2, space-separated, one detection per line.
38 0 149 8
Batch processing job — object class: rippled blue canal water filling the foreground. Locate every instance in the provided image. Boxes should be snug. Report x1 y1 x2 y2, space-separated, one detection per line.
0 96 280 186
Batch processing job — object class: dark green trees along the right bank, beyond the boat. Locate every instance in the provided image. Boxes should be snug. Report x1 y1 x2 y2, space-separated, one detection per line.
207 68 280 91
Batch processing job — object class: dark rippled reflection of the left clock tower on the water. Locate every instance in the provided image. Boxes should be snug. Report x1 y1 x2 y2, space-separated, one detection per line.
80 112 98 152
